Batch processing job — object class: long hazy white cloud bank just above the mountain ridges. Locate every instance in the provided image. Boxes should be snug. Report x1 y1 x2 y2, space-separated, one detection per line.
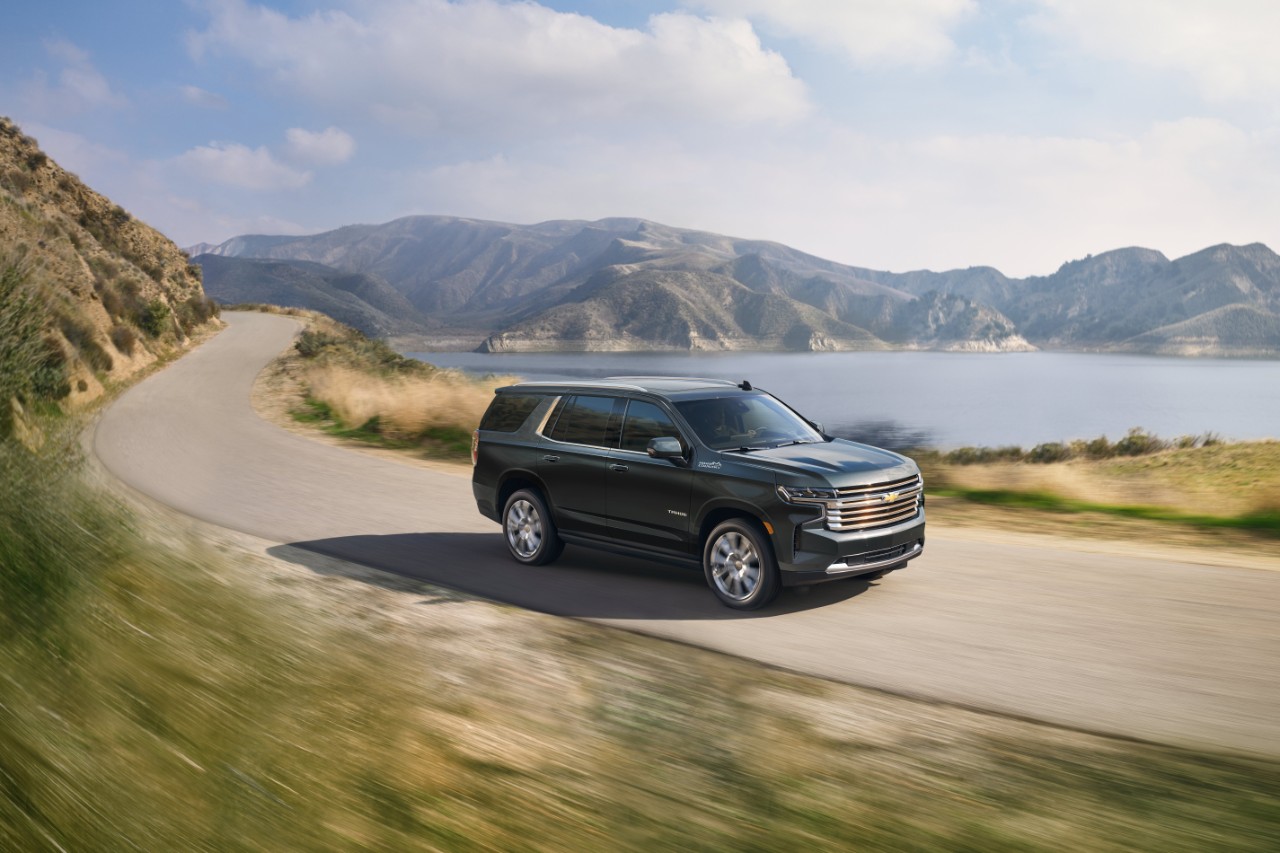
404 119 1280 275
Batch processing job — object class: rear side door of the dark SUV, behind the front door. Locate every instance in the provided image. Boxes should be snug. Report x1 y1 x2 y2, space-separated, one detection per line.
538 394 625 537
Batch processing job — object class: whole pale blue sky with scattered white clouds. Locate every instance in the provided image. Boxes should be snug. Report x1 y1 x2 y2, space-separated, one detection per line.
0 0 1280 275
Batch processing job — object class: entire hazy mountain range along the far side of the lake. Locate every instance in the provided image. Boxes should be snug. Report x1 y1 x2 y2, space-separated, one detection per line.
188 216 1280 355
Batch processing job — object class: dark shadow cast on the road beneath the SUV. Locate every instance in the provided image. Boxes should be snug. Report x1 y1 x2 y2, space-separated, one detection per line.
268 533 874 620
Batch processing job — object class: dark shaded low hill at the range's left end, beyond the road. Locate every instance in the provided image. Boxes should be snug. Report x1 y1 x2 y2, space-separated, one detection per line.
193 255 438 337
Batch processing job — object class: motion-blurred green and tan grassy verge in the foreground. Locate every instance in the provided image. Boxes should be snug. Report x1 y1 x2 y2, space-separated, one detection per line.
0 290 1280 850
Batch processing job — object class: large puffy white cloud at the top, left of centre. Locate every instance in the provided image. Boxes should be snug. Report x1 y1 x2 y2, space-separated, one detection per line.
188 0 810 134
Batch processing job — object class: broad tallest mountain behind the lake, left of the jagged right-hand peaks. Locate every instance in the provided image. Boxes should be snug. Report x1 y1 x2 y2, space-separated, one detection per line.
200 216 1030 351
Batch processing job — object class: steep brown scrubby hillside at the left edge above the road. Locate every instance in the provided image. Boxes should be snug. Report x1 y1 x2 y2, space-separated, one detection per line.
0 119 215 411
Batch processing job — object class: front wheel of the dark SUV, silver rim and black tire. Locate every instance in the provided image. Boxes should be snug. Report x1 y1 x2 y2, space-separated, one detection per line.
703 519 782 610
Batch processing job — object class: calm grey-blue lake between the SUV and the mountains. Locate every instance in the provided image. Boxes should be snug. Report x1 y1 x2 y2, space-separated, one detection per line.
407 352 1280 448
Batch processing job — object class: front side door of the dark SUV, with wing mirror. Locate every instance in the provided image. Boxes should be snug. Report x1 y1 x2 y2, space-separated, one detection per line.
608 400 694 553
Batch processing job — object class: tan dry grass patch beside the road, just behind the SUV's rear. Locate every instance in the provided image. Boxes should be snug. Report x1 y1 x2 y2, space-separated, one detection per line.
303 362 515 439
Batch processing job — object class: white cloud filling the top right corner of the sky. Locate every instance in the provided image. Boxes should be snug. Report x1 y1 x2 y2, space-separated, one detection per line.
1032 0 1280 101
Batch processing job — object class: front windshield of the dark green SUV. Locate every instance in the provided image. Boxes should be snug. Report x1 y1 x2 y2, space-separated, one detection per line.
676 394 823 450
